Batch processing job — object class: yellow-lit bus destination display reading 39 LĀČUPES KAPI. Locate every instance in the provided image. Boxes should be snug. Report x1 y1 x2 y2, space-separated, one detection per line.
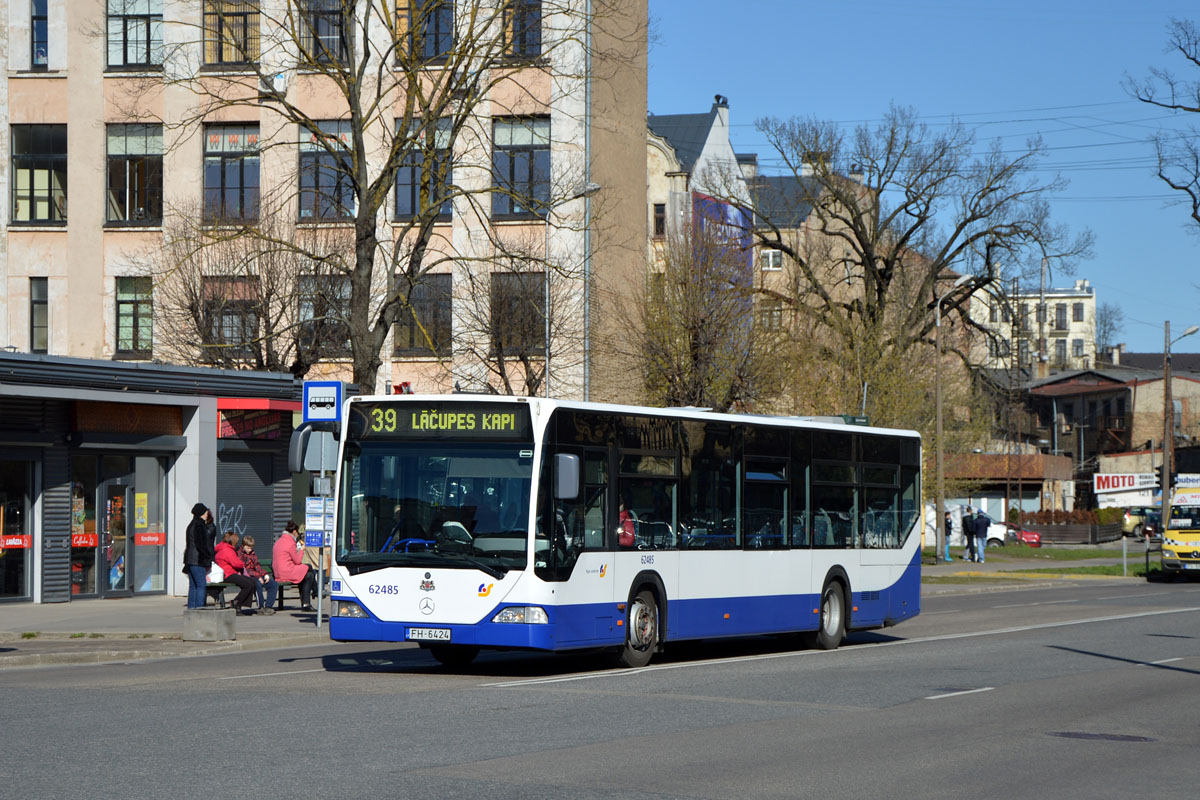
350 402 533 441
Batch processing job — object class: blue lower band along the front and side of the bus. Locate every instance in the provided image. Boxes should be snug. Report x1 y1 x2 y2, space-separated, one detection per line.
329 551 920 650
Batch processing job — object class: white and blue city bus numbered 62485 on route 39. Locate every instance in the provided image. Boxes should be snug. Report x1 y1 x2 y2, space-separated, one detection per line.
330 395 920 666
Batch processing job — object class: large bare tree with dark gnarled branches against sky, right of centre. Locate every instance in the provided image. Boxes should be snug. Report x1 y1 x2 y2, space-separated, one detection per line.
754 107 1092 381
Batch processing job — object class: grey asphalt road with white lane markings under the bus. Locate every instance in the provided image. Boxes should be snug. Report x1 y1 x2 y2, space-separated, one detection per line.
0 582 1200 800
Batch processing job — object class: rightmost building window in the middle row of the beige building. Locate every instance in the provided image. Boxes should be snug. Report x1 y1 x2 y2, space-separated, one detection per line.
492 118 550 217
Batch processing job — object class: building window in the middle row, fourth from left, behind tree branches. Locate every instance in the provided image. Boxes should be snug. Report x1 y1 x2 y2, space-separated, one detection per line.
300 120 356 221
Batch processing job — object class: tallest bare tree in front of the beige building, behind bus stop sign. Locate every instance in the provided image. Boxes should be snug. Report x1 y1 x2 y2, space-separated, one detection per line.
114 0 637 387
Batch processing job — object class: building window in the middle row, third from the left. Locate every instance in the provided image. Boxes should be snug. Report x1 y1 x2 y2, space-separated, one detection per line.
204 125 258 222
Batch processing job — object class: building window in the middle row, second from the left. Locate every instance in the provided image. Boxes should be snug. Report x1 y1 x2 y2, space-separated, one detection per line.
104 125 162 224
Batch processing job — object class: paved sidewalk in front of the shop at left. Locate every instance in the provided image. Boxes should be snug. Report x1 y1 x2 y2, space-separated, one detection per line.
0 595 330 669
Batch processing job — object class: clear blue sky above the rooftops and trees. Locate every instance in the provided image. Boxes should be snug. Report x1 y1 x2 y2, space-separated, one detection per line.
649 0 1200 353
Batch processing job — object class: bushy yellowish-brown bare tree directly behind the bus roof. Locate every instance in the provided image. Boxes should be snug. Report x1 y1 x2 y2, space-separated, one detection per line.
625 219 785 411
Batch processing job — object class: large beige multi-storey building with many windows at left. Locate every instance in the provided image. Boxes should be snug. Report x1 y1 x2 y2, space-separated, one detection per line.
0 0 648 399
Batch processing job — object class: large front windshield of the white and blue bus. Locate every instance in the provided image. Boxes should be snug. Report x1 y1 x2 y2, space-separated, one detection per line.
336 440 533 577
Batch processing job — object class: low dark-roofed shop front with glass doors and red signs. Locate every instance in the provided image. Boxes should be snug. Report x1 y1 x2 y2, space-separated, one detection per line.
0 353 300 603
